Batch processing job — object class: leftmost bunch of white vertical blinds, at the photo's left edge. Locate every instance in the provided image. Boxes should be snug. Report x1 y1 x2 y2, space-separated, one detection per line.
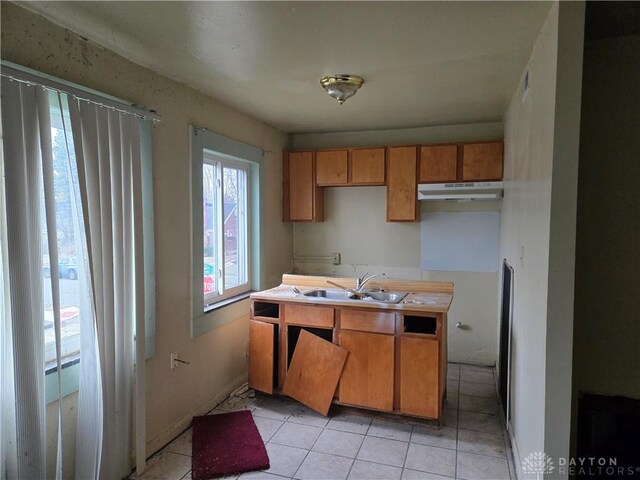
0 78 48 479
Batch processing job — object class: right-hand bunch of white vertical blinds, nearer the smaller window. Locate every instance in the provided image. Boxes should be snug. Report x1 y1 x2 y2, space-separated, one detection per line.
69 100 145 478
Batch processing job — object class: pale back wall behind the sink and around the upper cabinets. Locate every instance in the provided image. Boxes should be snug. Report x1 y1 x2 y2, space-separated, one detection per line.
292 123 502 365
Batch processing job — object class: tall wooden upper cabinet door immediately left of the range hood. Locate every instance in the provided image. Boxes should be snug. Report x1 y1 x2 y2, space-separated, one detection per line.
387 147 418 222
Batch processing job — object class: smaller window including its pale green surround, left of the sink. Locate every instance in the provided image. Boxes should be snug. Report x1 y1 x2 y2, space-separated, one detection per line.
191 126 262 324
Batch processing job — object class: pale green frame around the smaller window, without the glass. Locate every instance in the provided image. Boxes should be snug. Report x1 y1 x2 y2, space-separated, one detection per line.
189 125 263 337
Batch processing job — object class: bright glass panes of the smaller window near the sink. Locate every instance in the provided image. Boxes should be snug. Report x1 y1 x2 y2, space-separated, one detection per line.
202 151 249 306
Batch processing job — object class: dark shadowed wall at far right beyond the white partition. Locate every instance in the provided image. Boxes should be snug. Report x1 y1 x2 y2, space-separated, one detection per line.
573 35 640 450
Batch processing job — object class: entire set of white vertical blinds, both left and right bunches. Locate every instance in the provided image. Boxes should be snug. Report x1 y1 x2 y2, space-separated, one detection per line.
0 72 148 480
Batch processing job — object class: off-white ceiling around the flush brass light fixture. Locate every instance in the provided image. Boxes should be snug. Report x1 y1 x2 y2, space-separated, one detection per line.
20 1 550 132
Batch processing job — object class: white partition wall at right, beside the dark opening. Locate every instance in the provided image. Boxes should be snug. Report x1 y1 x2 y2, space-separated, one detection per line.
501 2 584 476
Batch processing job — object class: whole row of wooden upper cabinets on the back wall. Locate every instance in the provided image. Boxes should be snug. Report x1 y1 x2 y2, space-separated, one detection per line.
283 141 503 222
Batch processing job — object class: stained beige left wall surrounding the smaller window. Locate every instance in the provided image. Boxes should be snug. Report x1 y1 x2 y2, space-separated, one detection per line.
2 2 292 472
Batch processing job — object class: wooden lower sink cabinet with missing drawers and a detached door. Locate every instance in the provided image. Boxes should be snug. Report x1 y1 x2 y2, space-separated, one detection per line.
249 300 447 419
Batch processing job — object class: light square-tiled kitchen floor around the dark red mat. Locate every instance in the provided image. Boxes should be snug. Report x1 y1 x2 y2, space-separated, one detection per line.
136 363 515 480
